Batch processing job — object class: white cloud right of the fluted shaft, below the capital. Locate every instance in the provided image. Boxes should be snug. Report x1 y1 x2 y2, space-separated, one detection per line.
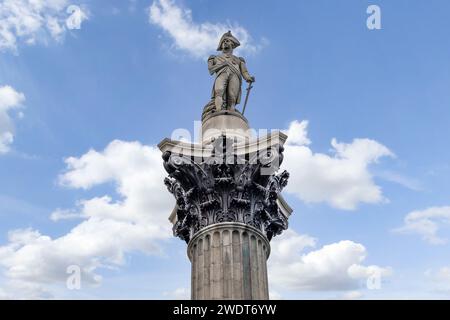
269 230 391 291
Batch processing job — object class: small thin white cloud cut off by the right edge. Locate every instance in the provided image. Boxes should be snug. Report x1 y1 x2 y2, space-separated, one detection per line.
393 206 450 245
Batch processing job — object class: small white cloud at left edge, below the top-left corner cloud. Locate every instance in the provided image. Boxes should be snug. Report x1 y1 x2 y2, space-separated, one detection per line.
0 86 25 154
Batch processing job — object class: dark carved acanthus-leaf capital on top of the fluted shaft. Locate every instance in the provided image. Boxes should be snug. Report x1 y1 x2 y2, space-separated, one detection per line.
163 136 289 242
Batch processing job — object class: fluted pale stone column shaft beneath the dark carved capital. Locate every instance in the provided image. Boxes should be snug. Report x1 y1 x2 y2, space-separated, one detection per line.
188 222 270 300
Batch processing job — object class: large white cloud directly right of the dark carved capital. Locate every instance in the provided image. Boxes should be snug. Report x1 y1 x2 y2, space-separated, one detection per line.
283 121 394 210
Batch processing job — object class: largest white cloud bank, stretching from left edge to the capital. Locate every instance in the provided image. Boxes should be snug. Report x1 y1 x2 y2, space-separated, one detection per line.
0 140 174 298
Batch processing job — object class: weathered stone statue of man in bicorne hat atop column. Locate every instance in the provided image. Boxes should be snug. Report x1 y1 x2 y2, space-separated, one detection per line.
203 31 255 116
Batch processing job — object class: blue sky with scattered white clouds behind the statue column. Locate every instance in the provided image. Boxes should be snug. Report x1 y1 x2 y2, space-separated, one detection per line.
0 0 450 299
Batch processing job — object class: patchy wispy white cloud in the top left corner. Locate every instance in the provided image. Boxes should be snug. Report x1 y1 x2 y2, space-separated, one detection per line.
0 0 88 52
